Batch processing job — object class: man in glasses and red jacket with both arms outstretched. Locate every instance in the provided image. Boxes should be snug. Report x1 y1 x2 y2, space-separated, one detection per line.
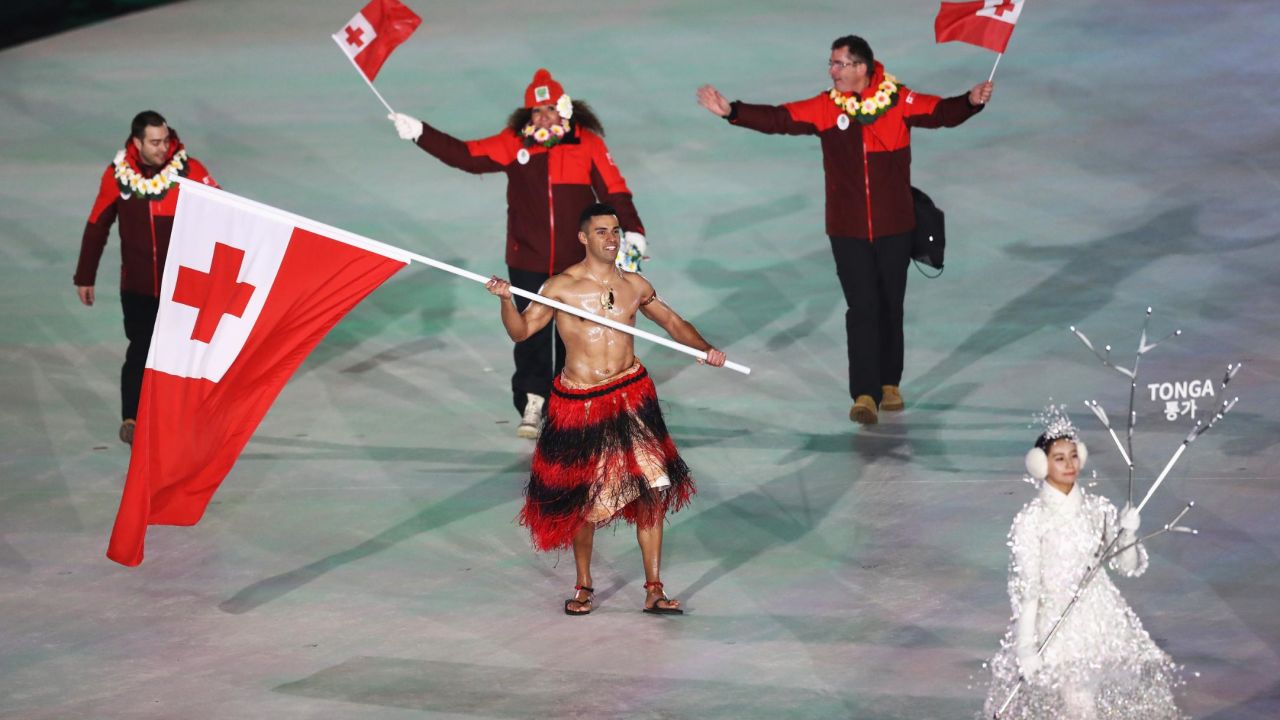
698 35 991 424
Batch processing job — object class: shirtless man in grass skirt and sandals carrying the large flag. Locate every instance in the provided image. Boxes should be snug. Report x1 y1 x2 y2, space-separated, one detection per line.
486 202 724 615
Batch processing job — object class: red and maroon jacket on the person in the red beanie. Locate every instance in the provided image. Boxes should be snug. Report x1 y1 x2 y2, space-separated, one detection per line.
417 123 644 274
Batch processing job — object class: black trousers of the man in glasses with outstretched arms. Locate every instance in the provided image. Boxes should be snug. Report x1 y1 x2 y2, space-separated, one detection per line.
829 234 911 405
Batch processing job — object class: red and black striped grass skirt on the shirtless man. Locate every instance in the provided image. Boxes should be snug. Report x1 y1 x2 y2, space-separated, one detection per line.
518 363 695 551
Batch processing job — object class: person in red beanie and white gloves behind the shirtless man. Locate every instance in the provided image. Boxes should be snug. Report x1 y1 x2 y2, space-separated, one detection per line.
390 69 645 438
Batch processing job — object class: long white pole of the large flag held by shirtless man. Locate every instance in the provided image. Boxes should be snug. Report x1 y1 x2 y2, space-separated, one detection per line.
173 178 751 375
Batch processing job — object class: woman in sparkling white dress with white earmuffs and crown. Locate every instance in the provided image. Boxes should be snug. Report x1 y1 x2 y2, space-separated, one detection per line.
983 407 1183 720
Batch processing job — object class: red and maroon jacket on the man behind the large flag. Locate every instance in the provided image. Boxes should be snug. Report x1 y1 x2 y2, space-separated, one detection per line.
73 129 218 297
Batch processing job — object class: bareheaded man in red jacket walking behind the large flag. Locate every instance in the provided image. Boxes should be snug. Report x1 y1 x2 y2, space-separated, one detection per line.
73 110 218 443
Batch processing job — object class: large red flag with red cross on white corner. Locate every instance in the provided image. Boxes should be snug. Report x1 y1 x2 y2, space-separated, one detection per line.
106 178 410 565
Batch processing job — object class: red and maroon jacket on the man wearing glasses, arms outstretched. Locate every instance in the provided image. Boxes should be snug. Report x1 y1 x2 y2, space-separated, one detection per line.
728 63 983 241
